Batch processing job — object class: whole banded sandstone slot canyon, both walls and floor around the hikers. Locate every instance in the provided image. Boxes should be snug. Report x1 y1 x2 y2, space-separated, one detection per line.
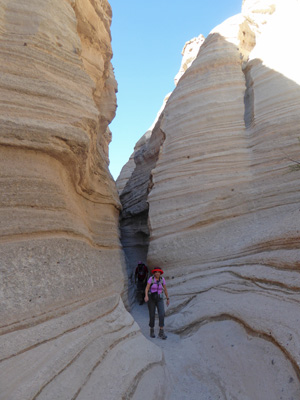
0 0 300 400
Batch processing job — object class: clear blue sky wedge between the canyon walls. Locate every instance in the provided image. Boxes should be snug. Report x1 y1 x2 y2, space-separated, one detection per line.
109 0 242 179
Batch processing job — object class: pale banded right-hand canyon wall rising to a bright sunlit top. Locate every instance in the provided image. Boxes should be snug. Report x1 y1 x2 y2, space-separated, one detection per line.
121 0 300 400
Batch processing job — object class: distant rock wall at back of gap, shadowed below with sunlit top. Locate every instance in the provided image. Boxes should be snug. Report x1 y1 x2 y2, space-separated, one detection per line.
116 35 204 300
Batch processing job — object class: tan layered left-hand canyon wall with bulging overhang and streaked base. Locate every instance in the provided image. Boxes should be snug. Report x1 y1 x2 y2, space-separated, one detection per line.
0 0 162 400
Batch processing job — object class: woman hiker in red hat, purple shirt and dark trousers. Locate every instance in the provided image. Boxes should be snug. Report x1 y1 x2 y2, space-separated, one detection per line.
145 268 170 339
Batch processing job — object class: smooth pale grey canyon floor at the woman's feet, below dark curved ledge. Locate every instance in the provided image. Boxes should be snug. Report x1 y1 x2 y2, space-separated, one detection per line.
131 304 300 400
